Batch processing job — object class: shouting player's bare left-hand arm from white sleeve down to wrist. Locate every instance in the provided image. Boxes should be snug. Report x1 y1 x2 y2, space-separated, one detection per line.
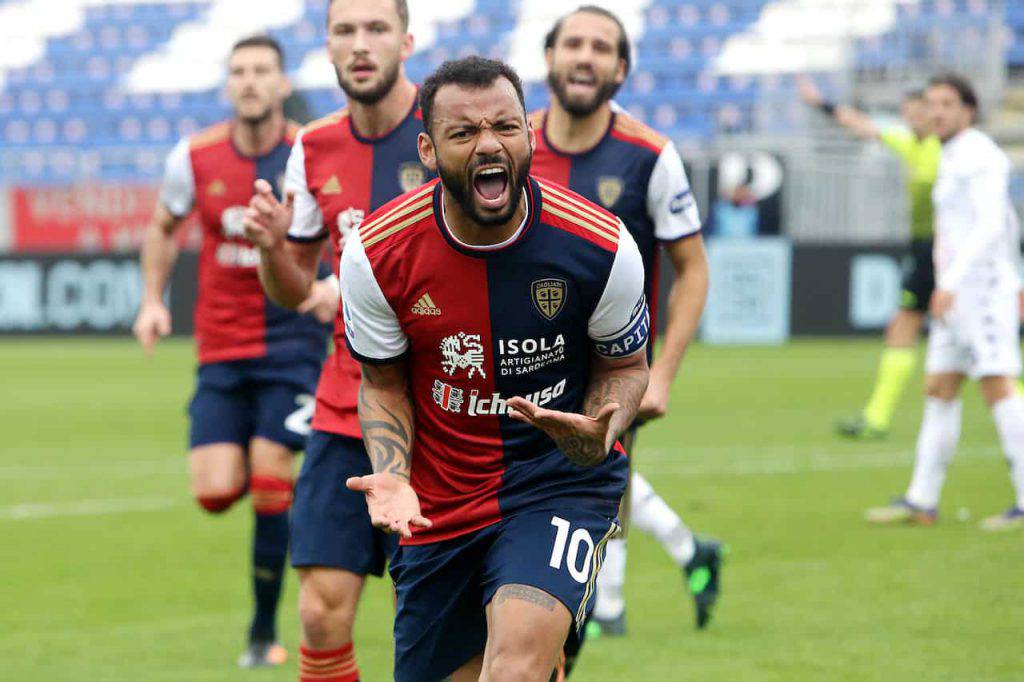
358 363 413 481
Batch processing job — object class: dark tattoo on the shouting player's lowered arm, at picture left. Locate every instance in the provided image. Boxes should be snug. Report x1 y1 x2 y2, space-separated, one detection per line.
359 370 413 480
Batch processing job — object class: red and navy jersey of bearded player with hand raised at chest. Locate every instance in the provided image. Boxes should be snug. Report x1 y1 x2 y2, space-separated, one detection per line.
285 104 431 438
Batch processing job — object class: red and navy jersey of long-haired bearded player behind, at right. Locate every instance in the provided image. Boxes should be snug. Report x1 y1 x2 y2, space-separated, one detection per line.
529 106 700 327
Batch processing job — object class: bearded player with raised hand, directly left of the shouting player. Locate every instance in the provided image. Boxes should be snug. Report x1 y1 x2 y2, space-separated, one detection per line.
246 0 429 682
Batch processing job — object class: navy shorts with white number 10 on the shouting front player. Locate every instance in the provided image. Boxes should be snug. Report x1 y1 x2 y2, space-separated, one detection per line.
390 498 618 682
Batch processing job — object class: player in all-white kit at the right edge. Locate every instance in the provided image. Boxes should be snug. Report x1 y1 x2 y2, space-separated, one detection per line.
867 75 1024 530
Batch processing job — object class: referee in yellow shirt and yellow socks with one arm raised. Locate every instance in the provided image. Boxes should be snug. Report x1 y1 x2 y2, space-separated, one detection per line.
799 78 942 438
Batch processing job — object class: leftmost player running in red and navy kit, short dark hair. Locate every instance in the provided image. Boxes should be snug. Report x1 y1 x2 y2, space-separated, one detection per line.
133 37 337 668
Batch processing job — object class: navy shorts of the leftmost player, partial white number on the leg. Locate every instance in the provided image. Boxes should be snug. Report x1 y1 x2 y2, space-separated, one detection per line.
188 358 321 451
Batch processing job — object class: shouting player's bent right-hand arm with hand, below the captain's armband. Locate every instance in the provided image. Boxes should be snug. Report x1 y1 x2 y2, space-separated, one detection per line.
508 351 649 467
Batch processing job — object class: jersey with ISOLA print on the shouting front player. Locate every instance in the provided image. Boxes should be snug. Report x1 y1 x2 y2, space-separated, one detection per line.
342 178 649 544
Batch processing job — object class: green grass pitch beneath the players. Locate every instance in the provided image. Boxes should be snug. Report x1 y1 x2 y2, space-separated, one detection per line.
0 339 1024 682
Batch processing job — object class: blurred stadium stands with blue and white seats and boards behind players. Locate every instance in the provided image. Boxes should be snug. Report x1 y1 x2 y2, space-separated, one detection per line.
0 0 1024 341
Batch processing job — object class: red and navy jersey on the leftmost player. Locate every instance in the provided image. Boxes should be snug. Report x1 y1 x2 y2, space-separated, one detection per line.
161 122 330 365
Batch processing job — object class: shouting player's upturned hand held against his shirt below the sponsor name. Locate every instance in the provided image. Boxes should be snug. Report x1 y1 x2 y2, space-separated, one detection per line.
508 397 618 467
